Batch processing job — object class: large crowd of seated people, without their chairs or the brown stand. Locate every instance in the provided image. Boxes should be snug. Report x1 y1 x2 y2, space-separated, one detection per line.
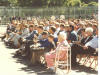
2 15 98 69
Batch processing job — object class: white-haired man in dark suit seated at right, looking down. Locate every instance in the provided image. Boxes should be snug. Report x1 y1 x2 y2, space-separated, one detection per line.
71 27 94 66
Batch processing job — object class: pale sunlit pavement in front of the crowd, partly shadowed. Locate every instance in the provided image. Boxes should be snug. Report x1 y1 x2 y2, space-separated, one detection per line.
0 28 97 75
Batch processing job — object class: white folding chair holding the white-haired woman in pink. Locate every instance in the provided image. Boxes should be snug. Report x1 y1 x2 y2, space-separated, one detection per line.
55 48 71 73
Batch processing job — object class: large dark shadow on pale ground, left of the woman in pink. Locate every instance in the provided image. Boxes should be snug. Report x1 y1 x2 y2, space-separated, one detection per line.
13 54 55 75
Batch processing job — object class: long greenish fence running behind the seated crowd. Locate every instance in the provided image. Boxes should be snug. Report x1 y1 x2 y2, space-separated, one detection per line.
0 7 98 24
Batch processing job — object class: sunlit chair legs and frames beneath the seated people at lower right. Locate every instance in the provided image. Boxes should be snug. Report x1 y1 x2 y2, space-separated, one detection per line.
77 50 98 70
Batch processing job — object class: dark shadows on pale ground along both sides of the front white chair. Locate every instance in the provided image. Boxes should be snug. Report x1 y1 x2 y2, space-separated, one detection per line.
13 52 98 75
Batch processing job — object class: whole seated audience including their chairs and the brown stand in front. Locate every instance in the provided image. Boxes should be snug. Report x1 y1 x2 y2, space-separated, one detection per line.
0 15 98 73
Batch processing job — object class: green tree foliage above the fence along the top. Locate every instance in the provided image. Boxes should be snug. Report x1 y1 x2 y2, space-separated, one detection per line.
0 0 98 7
